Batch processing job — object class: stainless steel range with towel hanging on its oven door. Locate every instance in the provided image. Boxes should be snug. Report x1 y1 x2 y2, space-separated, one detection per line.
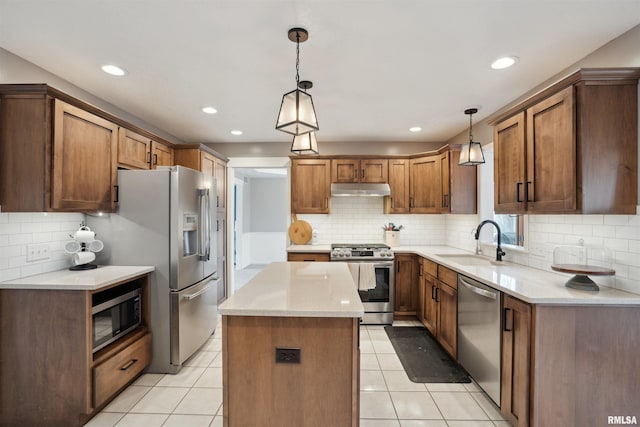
331 243 394 325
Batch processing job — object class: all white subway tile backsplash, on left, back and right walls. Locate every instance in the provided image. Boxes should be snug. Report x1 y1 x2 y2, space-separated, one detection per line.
0 205 640 294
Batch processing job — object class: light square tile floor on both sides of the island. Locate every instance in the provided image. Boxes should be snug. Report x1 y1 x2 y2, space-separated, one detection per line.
87 321 510 427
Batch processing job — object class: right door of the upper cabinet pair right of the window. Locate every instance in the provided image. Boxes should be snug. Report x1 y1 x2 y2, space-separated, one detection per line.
525 86 576 212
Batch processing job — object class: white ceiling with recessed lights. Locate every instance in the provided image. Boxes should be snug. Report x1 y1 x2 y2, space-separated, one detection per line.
0 0 640 143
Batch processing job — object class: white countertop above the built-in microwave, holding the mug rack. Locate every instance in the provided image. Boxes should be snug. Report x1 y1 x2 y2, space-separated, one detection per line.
0 265 155 291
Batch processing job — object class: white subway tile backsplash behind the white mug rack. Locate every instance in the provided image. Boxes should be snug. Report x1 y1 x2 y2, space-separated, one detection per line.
0 213 84 282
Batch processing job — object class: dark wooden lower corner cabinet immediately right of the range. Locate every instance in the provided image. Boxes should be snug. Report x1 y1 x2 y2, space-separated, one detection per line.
393 254 419 317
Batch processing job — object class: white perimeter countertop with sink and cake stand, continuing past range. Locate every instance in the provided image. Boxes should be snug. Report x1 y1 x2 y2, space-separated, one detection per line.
288 245 640 306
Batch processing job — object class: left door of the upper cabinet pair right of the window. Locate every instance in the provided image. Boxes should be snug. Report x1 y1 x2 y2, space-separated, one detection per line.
493 113 526 213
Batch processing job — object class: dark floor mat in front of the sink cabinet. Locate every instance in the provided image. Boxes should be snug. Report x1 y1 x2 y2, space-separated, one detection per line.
384 326 471 383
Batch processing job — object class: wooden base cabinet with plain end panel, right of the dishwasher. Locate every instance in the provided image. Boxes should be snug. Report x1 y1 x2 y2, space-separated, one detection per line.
500 295 640 427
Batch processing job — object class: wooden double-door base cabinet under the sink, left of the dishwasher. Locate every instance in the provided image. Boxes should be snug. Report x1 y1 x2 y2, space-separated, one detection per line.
418 258 458 358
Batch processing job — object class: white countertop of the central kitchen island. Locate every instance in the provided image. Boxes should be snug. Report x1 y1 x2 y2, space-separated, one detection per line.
218 262 364 317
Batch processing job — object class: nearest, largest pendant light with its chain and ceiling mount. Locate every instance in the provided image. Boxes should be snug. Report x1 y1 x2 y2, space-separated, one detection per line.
276 28 319 136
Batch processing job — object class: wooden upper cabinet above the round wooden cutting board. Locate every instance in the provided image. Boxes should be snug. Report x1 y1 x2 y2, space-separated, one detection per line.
291 158 331 214
